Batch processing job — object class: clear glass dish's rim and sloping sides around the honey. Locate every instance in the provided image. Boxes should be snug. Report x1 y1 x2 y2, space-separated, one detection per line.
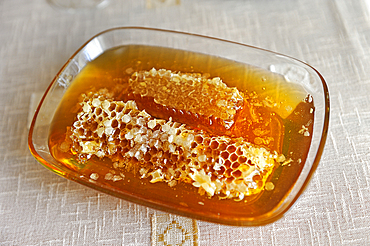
28 27 329 226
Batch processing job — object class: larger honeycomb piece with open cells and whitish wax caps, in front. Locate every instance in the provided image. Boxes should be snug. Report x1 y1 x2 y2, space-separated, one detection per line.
66 90 284 200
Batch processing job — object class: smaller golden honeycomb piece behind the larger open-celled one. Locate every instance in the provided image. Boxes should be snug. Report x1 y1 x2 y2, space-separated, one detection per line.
128 68 244 133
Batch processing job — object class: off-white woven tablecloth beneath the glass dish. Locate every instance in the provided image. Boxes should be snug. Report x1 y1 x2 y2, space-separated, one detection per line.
0 0 370 245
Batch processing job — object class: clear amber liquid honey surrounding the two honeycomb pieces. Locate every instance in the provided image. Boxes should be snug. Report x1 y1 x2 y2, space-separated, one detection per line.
49 46 314 221
